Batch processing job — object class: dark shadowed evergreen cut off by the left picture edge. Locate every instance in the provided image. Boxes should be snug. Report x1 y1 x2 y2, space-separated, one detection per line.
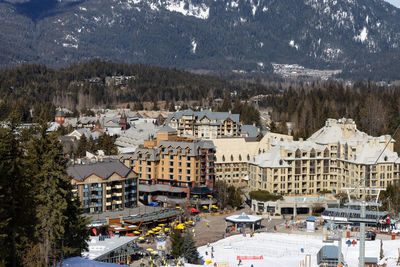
0 123 35 266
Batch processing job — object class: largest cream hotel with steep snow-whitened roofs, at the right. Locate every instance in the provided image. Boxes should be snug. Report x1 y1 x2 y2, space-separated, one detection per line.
248 119 400 195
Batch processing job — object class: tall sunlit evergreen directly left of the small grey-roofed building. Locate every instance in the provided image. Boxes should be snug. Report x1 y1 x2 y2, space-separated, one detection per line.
27 123 86 266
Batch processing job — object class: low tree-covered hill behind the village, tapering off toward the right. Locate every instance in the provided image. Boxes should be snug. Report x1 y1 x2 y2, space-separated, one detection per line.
0 60 271 116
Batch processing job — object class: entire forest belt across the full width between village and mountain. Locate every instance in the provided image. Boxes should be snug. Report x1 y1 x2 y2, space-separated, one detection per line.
0 60 400 147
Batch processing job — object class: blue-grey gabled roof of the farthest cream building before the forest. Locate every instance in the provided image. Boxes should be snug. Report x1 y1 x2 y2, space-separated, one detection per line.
167 109 240 124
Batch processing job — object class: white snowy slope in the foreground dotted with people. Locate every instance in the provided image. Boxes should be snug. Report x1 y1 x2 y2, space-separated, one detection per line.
195 233 400 267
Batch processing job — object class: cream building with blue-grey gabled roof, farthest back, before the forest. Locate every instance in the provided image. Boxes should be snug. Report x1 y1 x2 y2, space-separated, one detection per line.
167 109 241 139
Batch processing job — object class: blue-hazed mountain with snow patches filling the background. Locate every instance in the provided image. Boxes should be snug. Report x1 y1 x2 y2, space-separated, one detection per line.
0 0 400 79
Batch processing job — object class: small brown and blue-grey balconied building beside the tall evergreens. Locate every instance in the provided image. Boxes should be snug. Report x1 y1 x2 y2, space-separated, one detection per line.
67 160 139 213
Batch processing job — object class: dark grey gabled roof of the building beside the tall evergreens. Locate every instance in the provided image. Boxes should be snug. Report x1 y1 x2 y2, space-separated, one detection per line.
67 160 131 182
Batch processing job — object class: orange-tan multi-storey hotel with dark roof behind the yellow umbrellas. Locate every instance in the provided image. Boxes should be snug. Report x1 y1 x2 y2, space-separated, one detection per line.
121 127 215 199
